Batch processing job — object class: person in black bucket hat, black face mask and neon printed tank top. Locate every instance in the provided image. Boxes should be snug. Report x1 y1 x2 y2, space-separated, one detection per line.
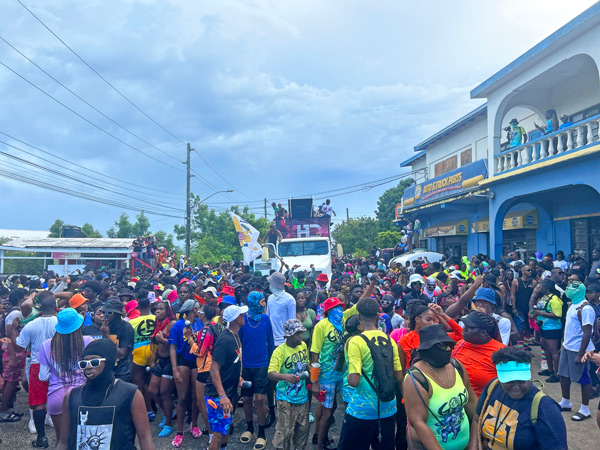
402 324 477 450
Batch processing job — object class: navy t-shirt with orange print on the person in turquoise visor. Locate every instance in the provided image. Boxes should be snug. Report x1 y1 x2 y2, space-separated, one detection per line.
477 378 567 450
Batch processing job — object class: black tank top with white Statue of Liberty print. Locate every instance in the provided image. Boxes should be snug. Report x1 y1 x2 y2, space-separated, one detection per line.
69 380 137 450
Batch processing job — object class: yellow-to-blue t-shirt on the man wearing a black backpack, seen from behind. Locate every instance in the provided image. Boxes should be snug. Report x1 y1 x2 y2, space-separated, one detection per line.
346 330 402 420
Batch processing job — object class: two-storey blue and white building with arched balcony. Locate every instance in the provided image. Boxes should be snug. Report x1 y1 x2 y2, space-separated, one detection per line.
397 3 600 260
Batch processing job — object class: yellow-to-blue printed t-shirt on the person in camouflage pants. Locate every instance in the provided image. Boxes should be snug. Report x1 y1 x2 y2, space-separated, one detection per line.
269 341 308 405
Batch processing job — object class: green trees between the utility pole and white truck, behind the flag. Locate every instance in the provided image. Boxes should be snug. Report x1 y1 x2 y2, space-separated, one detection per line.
175 205 269 264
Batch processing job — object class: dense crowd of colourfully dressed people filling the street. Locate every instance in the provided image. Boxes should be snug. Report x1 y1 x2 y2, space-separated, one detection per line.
0 250 600 450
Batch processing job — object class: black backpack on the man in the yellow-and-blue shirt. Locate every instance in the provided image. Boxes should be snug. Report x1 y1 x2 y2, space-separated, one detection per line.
359 334 396 404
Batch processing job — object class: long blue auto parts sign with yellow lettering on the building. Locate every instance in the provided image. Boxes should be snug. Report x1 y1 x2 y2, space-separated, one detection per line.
402 159 488 208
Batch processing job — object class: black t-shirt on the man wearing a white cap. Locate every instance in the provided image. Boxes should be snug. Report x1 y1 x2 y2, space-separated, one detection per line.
205 328 242 402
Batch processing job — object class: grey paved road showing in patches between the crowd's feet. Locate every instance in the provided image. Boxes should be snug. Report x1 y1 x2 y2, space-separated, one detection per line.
0 347 600 450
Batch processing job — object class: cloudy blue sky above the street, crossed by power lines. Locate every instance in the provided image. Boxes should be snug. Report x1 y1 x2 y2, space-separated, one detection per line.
0 0 594 237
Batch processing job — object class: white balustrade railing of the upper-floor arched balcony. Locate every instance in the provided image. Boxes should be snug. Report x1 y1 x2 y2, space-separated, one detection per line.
494 114 600 175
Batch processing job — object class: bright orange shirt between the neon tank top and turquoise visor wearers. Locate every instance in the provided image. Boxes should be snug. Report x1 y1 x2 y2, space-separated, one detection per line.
452 339 506 396
